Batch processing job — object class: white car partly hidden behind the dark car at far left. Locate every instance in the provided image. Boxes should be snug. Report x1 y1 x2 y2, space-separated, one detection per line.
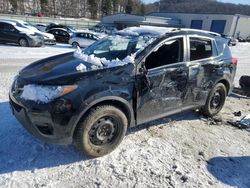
14 20 56 45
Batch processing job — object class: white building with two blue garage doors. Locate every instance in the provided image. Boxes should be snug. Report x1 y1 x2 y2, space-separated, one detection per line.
149 12 250 38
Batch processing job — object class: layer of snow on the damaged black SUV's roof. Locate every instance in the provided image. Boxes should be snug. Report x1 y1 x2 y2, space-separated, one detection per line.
116 26 176 36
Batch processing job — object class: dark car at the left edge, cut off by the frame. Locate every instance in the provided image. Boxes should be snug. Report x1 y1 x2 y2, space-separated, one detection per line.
0 20 44 47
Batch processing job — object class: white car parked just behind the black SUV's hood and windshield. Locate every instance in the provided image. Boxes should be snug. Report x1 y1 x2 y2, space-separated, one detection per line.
69 30 106 48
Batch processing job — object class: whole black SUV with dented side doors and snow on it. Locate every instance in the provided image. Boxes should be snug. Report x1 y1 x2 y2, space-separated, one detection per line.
9 27 237 157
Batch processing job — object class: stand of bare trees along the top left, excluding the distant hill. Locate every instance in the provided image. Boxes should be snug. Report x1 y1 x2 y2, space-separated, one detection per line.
0 0 145 18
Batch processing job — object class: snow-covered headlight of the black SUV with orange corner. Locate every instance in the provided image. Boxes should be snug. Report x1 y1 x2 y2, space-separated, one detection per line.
21 84 77 103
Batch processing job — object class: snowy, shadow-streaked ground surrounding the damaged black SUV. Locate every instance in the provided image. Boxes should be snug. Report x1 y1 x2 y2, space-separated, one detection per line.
0 44 250 188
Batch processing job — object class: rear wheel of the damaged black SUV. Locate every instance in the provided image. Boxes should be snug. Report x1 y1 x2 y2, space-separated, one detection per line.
202 83 227 117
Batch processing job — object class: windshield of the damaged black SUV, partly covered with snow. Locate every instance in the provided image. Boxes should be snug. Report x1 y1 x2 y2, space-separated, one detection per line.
83 35 155 60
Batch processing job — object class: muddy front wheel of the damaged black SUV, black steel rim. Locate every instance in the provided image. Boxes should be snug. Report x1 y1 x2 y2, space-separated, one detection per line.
74 105 128 157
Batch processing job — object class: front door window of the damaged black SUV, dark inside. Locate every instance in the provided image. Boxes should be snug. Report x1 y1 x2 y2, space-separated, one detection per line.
145 38 183 69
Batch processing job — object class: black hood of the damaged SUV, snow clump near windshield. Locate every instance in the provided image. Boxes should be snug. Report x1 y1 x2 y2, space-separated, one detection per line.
18 52 132 85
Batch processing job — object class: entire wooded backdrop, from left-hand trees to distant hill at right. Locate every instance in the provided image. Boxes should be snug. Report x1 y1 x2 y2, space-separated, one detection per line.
0 0 250 18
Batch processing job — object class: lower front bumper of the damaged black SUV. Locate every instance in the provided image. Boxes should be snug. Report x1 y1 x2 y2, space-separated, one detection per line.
9 93 72 144
